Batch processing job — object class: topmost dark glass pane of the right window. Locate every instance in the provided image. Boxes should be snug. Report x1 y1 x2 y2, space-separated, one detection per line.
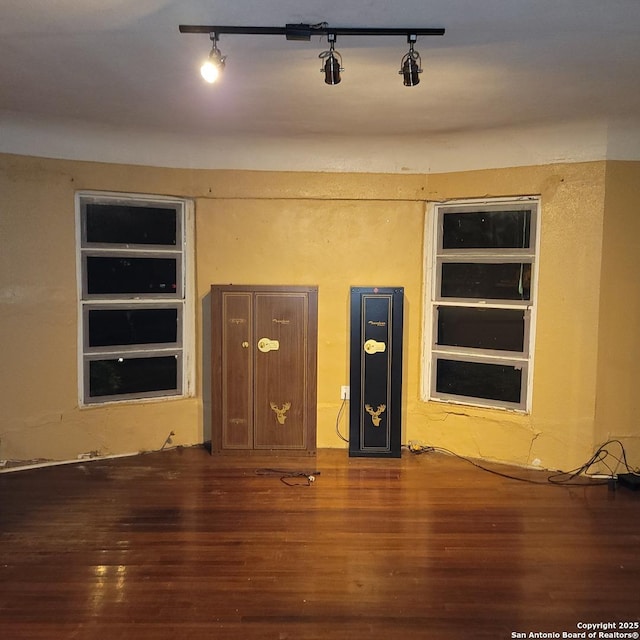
442 210 531 249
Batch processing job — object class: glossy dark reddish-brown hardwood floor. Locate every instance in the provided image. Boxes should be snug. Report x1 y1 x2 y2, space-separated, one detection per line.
0 448 640 640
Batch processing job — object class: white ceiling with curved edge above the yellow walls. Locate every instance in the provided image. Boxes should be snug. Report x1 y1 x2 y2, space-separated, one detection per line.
0 0 640 171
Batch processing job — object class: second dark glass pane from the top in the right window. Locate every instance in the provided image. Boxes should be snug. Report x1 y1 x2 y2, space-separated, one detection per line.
441 262 531 300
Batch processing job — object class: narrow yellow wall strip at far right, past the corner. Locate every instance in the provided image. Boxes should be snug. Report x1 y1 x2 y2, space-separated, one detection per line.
595 162 640 466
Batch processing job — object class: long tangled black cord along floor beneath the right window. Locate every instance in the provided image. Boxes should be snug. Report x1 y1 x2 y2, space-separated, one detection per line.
407 440 638 487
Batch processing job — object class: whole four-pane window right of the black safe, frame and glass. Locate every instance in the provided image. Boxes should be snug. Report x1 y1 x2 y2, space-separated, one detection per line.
425 197 540 411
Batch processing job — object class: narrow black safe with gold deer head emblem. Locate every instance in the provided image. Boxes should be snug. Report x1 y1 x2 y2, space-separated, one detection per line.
349 287 404 458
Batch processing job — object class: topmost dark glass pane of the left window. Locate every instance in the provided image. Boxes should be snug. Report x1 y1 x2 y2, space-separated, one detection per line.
86 204 177 246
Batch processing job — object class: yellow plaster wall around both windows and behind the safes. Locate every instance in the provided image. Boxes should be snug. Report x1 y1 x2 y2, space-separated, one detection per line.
0 155 636 468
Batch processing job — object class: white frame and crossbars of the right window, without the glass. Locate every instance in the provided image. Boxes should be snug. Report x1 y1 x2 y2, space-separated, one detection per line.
422 196 541 413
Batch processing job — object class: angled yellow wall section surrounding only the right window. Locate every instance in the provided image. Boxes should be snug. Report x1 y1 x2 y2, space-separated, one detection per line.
412 163 606 469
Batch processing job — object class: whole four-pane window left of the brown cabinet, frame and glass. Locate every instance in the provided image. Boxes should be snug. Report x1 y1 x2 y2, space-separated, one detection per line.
76 192 193 405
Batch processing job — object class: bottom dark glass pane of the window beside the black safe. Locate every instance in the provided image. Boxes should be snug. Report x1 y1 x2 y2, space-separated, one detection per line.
436 358 522 404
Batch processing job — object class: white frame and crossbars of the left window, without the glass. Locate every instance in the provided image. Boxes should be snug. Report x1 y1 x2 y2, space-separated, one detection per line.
75 191 195 407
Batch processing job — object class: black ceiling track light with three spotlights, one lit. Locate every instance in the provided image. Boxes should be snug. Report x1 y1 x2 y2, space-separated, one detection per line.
179 22 444 87
